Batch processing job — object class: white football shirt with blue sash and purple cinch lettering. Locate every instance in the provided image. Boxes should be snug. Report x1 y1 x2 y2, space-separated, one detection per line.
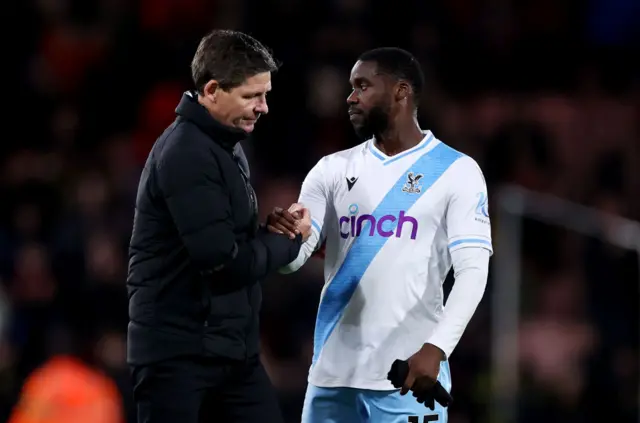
281 131 492 390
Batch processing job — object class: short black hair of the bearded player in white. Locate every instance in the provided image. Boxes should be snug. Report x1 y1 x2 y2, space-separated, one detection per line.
358 47 424 107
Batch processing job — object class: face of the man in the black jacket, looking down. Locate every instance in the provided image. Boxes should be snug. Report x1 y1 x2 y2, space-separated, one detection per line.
213 72 271 133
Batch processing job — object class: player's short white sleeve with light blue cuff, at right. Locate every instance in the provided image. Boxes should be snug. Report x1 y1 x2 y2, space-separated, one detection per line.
446 156 493 253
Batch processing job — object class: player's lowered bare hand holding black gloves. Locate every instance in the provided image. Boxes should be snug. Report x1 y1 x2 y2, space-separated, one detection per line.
400 344 445 400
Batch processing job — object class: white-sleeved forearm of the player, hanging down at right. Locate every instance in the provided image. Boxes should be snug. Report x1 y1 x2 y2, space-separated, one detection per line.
427 247 490 357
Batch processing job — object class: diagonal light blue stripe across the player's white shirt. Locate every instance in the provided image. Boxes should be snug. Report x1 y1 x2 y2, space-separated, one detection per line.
313 143 462 363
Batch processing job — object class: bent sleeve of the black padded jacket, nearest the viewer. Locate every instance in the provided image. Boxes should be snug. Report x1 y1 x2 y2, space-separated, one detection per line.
157 142 302 285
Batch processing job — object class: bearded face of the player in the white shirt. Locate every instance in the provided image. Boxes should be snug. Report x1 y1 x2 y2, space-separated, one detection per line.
347 61 392 140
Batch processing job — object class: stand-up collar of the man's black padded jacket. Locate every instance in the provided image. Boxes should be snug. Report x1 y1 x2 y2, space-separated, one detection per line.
176 91 249 151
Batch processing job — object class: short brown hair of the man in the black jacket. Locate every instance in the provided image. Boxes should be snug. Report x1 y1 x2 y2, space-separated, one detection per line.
191 29 279 94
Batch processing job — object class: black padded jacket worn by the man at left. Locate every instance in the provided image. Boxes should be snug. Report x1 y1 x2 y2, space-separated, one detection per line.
127 92 302 365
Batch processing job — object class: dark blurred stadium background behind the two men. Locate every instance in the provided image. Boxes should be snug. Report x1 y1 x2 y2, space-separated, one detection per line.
0 0 640 423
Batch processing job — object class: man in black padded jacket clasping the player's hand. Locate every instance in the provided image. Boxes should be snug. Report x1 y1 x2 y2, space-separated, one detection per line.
127 31 311 423
